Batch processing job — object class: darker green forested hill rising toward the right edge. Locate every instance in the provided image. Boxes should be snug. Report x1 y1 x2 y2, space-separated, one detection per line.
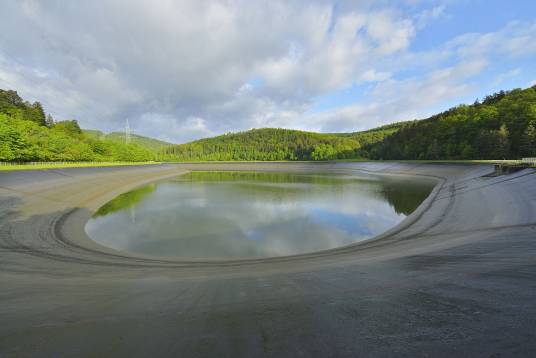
360 86 536 159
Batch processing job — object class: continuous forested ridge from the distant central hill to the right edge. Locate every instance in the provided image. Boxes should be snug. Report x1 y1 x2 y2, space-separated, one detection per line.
164 86 536 161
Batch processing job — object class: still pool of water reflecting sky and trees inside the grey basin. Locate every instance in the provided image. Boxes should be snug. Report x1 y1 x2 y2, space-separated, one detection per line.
86 172 434 259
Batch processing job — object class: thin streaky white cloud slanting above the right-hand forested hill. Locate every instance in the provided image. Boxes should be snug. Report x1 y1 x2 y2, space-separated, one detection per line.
299 19 536 132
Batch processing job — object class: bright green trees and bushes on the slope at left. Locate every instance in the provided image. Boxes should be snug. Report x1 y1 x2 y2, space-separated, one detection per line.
0 90 157 162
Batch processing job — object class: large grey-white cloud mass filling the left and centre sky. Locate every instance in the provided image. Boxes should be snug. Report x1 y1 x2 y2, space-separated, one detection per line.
0 0 426 141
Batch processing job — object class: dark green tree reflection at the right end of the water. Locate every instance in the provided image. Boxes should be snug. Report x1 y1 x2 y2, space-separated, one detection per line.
379 180 434 216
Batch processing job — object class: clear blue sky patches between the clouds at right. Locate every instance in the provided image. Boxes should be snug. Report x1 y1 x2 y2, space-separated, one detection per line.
309 0 536 120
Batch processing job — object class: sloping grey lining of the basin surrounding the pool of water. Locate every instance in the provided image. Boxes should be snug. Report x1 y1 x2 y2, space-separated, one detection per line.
0 163 536 357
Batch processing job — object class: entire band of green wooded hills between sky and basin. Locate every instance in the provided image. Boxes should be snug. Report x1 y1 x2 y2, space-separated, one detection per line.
0 86 536 162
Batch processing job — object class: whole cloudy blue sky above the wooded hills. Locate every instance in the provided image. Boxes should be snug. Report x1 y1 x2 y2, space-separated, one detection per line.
0 0 536 143
